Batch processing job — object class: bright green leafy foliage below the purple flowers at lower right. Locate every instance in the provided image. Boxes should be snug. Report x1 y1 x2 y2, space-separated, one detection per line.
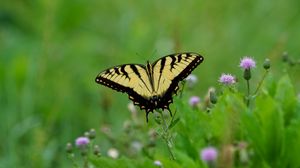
64 75 300 168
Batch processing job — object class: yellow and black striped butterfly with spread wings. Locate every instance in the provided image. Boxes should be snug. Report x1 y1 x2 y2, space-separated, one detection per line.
95 52 204 122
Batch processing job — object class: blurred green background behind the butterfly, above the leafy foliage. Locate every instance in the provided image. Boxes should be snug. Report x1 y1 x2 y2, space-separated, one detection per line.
0 0 300 167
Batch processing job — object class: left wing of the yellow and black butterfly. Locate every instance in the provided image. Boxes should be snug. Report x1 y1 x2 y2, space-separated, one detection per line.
95 64 153 110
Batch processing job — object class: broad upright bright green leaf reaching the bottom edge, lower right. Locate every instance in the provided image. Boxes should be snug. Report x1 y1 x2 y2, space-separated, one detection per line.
251 94 284 167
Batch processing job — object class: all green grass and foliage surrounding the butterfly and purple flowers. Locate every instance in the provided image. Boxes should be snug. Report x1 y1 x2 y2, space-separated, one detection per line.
0 0 300 167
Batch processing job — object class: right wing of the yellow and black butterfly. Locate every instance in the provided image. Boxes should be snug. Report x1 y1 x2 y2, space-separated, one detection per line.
152 53 204 109
